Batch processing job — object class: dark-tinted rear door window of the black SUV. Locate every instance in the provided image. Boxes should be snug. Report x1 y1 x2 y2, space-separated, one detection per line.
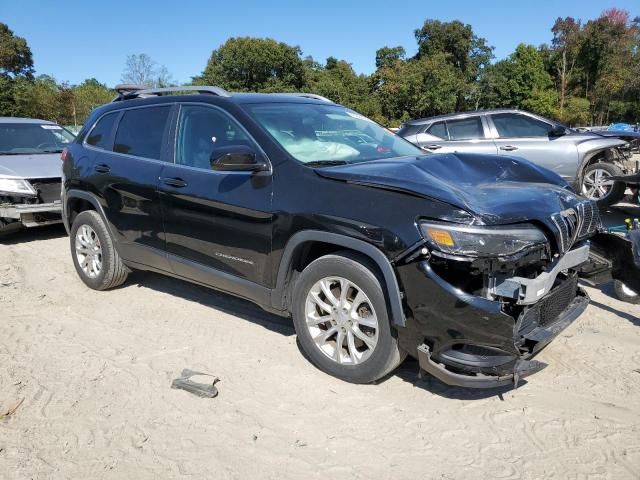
113 106 171 160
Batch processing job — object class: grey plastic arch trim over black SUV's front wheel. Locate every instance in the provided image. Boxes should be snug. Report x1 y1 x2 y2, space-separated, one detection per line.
272 230 405 326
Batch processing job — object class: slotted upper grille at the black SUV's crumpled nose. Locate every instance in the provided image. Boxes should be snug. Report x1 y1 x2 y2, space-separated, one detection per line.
551 200 600 253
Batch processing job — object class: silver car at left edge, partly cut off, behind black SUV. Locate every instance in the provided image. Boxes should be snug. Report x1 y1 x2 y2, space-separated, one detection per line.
0 117 74 235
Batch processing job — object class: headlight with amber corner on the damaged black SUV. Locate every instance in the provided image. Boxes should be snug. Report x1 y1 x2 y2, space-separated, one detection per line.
420 222 547 257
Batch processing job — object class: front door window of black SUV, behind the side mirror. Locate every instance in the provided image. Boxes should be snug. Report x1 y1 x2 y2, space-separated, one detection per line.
176 105 255 170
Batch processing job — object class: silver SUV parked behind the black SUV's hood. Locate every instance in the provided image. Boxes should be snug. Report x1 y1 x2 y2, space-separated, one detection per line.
398 109 630 205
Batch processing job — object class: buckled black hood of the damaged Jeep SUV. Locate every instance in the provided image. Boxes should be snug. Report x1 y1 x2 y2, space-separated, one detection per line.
316 153 579 225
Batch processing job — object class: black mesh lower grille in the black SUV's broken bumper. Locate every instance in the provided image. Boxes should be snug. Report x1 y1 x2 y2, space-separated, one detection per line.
518 273 578 335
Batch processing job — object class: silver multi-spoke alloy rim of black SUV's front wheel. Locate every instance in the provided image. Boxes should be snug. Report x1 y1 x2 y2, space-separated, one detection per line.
305 277 379 365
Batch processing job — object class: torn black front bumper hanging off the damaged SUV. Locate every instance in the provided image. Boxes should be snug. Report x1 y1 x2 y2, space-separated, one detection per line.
399 255 589 388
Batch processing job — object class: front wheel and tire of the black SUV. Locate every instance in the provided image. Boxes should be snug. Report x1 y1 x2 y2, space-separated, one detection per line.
293 252 406 383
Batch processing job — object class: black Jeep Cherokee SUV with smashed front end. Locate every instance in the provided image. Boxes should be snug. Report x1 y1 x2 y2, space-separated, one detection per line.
63 87 600 387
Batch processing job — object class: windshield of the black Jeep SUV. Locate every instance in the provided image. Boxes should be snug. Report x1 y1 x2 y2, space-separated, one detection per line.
246 103 424 165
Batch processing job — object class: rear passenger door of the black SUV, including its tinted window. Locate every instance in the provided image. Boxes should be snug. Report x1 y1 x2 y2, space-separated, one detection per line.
86 105 173 270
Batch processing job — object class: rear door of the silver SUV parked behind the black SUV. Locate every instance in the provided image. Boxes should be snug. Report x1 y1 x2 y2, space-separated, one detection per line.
417 115 496 154
